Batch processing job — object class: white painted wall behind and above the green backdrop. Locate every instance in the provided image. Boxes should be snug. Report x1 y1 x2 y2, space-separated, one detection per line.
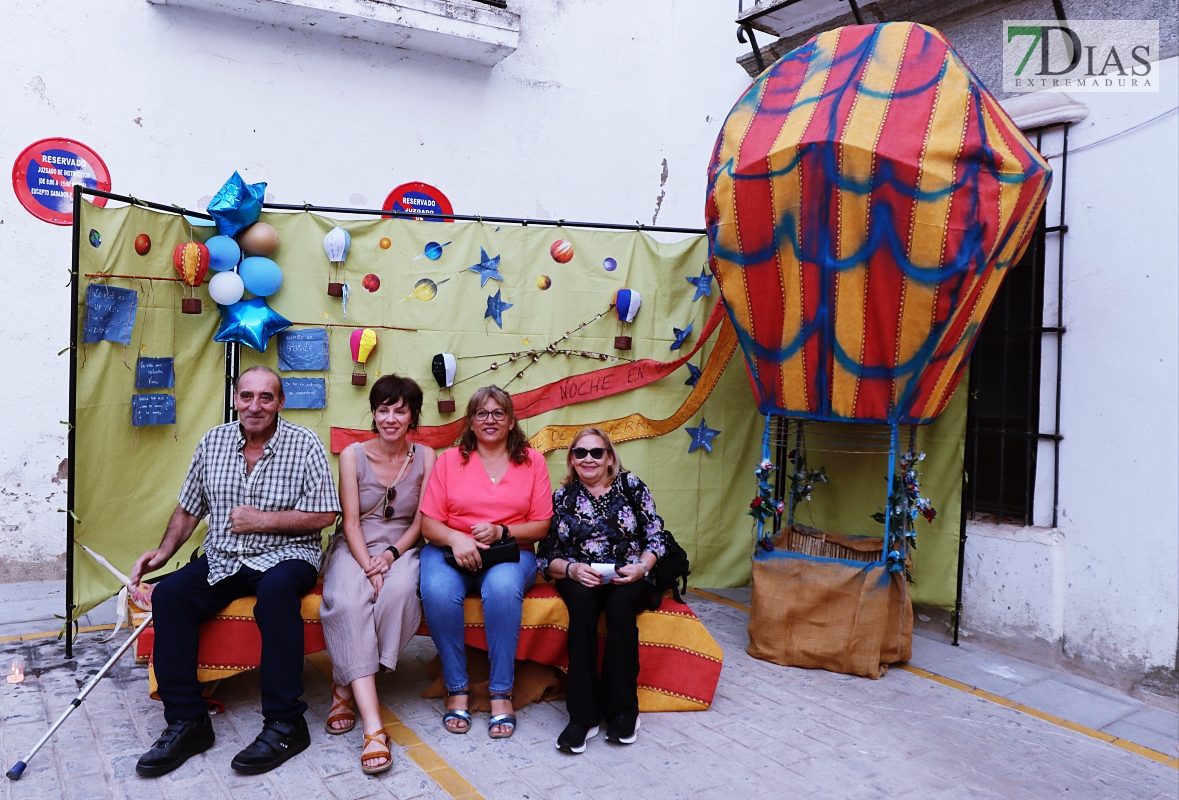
0 0 749 581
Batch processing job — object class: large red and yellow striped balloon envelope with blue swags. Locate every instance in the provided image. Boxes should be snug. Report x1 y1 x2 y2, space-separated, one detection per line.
705 22 1050 424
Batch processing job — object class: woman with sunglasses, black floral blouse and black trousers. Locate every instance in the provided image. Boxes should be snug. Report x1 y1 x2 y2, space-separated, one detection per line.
536 428 666 753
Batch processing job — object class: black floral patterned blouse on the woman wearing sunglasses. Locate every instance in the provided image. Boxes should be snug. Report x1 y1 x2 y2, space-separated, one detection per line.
536 472 666 582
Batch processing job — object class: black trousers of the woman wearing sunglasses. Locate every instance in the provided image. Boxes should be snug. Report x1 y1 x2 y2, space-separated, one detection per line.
556 580 656 728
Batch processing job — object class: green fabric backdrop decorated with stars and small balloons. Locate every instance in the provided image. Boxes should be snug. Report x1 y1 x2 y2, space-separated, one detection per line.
74 204 964 614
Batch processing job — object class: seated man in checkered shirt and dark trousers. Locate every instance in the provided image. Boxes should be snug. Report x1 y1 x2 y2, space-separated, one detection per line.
131 366 340 776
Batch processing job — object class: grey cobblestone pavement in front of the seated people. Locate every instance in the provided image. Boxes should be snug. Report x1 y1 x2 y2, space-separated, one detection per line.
0 595 1179 800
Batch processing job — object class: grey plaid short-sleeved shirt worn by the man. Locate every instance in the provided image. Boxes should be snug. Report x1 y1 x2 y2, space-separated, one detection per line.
179 417 340 584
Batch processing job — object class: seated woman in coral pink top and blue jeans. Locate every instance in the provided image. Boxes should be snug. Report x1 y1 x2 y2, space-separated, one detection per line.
421 386 553 739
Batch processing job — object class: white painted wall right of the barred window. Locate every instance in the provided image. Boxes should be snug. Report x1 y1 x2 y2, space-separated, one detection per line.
963 58 1179 681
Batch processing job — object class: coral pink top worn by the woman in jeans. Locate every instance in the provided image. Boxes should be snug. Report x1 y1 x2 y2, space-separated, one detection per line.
422 448 553 550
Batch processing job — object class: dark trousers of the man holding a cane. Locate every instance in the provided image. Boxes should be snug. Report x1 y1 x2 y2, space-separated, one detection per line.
151 556 317 722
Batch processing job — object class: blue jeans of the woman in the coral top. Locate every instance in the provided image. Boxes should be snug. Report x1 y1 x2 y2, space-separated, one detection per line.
421 544 536 694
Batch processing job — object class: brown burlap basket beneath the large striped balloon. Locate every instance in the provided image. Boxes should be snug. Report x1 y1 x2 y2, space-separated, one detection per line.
746 528 913 679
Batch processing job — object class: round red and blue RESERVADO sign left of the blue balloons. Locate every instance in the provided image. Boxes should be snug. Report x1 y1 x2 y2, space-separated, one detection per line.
12 138 111 225
